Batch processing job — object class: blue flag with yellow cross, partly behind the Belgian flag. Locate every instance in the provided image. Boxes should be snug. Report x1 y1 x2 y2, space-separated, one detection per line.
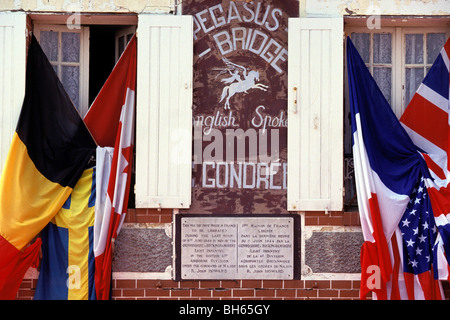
34 168 95 300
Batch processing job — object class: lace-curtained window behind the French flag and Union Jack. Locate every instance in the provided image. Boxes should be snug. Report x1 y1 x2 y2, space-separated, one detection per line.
344 25 450 210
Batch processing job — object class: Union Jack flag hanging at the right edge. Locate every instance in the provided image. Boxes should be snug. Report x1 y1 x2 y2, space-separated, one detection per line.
400 38 450 280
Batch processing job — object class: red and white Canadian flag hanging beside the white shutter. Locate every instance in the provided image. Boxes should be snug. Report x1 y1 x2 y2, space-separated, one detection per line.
84 35 136 300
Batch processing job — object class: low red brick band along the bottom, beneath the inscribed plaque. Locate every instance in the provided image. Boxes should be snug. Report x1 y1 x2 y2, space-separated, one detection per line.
17 279 359 300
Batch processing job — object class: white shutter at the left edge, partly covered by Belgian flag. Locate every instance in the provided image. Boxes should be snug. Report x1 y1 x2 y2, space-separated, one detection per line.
0 12 26 173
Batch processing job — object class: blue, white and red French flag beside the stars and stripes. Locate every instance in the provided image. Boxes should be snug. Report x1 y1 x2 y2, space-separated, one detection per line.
347 38 420 298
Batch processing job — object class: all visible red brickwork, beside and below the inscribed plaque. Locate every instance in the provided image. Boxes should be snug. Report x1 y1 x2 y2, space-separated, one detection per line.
17 209 450 300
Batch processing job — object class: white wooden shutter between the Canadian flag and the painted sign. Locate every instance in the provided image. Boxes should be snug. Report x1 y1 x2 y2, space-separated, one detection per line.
136 14 193 208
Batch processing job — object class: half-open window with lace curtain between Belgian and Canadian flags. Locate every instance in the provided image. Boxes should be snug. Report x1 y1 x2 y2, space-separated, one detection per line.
34 21 136 117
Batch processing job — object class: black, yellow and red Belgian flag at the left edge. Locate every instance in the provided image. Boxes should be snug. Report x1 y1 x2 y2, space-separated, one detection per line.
0 36 96 299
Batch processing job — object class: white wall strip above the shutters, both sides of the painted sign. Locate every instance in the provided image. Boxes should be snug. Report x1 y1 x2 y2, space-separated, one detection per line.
0 0 450 17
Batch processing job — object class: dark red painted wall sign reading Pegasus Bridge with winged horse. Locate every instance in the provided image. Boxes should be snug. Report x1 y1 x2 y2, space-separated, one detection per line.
182 0 299 213
